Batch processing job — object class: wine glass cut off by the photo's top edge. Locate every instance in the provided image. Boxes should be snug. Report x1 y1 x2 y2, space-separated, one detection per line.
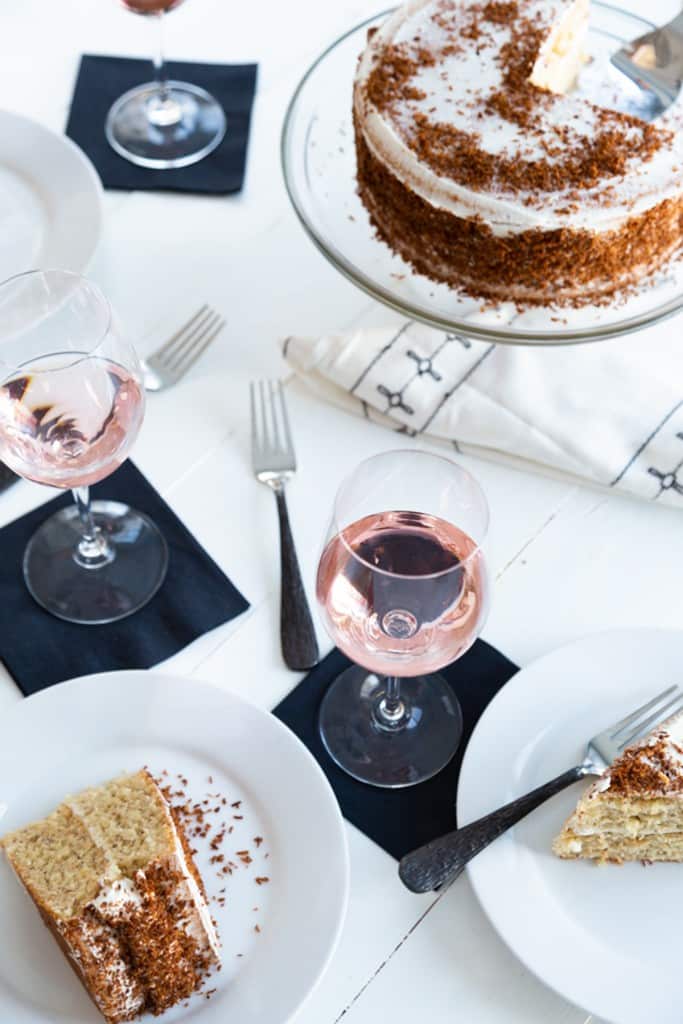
104 0 226 170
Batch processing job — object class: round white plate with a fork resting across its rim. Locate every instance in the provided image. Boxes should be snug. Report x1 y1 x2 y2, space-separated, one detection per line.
458 630 683 1024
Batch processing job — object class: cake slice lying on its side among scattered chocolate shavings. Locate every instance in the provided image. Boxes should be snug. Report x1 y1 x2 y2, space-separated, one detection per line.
1 770 219 1024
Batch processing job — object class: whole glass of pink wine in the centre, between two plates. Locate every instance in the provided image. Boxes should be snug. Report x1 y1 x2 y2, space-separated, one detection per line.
316 451 488 788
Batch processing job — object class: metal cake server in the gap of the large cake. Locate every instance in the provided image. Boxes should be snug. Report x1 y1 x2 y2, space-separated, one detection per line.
611 11 683 120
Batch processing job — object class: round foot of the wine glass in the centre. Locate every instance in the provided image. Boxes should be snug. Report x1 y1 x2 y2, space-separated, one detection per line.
319 666 463 799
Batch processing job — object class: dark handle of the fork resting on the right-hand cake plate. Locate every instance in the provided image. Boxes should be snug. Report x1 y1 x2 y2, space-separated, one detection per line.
398 765 587 893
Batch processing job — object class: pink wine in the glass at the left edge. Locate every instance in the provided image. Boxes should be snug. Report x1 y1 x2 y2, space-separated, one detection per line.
0 352 144 487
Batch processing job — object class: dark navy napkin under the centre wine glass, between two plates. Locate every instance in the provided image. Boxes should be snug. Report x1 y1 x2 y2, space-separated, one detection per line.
273 640 518 860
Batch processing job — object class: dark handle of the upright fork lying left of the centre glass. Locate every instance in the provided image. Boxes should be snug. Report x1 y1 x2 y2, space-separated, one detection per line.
275 485 321 672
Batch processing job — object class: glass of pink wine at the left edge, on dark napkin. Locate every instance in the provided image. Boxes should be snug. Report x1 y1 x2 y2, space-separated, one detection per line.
0 270 168 624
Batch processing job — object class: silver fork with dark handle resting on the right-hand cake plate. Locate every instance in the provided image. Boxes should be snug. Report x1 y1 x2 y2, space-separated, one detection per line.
398 686 683 893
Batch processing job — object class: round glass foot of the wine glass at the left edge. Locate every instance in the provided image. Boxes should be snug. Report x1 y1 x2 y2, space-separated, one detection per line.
24 502 168 626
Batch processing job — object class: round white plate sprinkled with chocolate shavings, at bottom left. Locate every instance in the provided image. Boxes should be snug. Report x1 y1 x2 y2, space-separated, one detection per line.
0 671 348 1024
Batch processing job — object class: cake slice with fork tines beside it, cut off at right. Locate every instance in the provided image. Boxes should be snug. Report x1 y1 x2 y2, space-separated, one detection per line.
553 715 683 863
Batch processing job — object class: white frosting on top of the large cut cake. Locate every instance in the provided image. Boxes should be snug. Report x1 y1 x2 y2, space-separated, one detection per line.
354 0 683 234
